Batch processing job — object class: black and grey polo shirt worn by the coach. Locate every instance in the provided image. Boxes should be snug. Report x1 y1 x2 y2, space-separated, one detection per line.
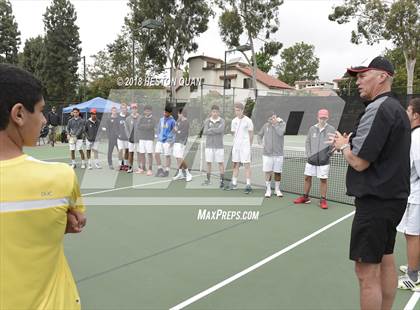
346 93 411 199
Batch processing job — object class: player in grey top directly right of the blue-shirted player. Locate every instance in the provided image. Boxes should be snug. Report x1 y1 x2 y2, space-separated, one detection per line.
173 108 192 182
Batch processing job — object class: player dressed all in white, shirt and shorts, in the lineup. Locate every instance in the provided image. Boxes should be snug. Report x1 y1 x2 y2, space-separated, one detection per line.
225 103 254 194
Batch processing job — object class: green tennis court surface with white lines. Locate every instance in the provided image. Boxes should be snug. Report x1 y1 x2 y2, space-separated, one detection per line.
26 145 420 309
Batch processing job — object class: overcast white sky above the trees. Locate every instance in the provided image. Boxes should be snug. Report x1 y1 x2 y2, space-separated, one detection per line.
11 0 392 81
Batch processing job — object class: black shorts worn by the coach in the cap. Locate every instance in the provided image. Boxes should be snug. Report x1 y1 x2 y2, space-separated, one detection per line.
350 197 407 264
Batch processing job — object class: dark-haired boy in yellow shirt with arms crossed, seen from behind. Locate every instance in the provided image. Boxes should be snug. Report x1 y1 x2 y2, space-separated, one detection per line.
0 64 86 310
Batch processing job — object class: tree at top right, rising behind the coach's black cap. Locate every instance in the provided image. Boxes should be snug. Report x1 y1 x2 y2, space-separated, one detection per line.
328 0 420 94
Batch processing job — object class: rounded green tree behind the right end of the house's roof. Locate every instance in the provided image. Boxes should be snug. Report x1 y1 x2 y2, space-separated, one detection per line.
277 42 319 85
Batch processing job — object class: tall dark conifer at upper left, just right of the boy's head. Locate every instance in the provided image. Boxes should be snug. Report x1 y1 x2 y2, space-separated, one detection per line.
42 0 81 102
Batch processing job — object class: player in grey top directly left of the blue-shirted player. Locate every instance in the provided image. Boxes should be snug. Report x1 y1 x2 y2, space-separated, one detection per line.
139 105 156 176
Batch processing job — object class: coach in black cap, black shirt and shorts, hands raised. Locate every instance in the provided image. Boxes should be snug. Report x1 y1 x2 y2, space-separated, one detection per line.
334 57 411 309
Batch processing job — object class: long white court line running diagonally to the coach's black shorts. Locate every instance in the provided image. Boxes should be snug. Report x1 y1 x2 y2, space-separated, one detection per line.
169 211 355 310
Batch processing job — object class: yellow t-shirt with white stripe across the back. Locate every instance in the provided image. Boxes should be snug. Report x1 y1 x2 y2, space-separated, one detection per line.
0 155 85 310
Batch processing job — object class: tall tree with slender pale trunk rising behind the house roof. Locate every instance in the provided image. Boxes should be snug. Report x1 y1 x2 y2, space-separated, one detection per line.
215 0 283 97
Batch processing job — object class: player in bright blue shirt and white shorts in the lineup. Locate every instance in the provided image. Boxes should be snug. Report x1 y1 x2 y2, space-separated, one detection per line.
155 106 175 177
